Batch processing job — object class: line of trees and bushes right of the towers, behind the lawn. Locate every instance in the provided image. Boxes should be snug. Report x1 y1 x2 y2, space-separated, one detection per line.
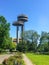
17 30 49 53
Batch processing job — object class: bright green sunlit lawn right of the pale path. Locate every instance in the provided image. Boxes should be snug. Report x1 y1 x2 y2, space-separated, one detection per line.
26 53 49 65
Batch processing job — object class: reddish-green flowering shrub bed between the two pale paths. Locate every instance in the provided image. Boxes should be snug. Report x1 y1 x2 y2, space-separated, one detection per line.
3 52 24 65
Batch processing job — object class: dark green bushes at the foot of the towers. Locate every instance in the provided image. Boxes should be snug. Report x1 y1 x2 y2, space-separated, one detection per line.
16 42 36 52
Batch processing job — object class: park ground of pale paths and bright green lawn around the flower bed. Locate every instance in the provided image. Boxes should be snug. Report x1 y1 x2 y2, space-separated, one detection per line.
0 53 49 65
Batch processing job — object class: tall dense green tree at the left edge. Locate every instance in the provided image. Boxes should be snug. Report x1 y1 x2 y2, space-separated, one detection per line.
0 16 10 49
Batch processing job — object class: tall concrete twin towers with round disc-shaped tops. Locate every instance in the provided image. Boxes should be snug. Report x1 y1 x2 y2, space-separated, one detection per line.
13 14 28 43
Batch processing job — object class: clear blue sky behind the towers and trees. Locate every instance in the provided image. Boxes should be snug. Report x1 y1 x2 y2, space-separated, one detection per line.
0 0 49 37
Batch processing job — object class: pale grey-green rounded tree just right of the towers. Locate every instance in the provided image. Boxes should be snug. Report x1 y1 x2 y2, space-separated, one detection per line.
23 30 39 51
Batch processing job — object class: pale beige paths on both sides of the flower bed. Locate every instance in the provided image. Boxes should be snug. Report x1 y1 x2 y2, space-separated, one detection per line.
0 54 33 65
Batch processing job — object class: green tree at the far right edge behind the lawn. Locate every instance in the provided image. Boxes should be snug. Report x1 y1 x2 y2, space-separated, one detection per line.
39 32 49 52
